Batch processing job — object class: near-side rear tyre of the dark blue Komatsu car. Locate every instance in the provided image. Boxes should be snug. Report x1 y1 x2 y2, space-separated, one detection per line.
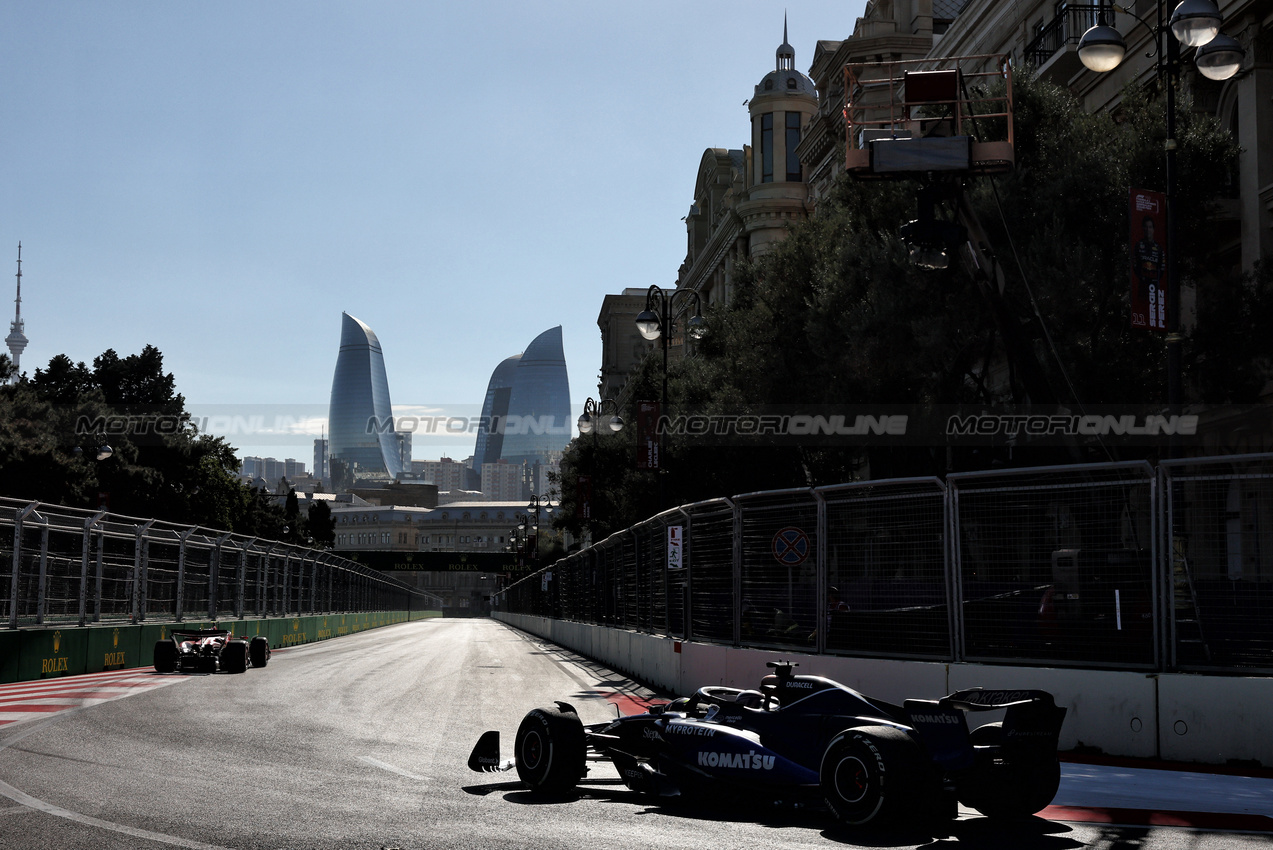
819 727 924 826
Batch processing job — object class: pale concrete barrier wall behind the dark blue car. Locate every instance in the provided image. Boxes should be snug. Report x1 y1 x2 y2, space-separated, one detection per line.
495 612 1273 765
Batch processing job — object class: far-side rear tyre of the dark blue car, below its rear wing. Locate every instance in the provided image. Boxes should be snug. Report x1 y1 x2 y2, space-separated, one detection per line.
960 723 1060 819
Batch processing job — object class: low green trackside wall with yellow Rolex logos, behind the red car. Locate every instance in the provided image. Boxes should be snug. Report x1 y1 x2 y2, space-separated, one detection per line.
0 611 439 685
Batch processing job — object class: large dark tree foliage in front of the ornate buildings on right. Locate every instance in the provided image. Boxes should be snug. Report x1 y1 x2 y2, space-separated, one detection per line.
558 75 1273 538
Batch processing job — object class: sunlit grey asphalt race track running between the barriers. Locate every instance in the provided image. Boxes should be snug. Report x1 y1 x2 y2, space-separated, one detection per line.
0 620 1273 850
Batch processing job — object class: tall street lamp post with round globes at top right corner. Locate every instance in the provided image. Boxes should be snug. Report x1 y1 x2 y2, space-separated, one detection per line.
1078 0 1245 425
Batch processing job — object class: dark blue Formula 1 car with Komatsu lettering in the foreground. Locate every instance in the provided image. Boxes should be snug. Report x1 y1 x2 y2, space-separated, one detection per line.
468 662 1066 826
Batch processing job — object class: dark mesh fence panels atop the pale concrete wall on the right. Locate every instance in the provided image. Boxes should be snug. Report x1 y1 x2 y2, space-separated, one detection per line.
496 454 1273 673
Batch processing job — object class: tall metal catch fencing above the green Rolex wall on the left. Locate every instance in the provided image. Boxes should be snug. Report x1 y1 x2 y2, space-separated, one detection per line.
0 499 440 629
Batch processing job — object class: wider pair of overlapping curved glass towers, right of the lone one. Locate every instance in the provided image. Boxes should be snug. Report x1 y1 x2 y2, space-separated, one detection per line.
474 324 570 463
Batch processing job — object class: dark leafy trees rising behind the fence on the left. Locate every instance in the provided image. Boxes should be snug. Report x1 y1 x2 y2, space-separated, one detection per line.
0 346 285 537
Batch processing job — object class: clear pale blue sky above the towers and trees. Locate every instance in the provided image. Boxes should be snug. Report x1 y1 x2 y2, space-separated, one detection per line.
0 0 866 466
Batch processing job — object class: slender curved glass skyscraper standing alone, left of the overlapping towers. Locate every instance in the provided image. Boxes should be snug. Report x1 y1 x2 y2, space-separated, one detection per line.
327 313 402 486
